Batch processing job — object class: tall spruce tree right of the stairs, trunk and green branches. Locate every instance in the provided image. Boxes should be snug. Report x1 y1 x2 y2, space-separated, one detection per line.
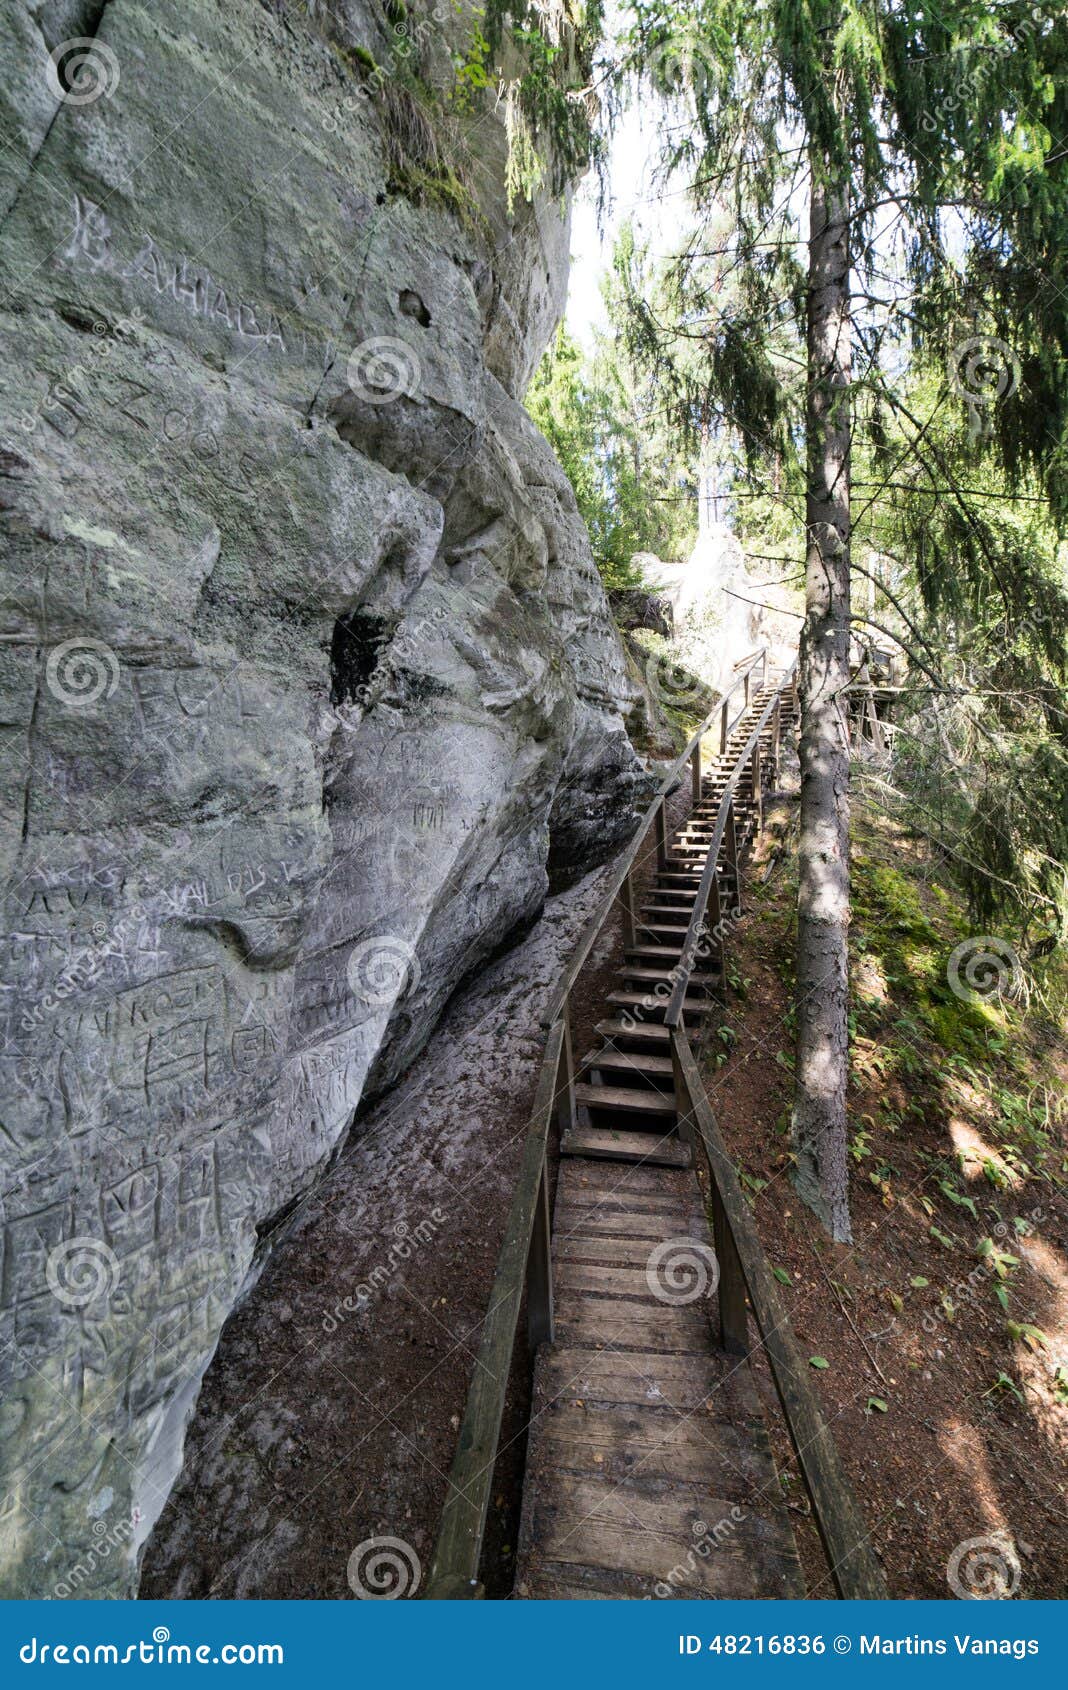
618 0 1068 1239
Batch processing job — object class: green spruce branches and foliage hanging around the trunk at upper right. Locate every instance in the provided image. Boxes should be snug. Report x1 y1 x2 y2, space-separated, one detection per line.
608 0 1068 945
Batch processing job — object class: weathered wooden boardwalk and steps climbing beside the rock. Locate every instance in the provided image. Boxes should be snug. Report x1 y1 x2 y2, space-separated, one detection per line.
514 688 804 1599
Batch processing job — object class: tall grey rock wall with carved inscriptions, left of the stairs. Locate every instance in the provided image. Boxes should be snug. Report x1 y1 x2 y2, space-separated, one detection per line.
0 0 642 1595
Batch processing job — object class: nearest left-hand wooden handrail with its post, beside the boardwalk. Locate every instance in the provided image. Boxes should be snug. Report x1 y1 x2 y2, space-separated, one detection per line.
422 1021 568 1600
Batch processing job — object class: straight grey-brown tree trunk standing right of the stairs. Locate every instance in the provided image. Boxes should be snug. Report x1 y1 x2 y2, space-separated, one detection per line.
793 154 850 1240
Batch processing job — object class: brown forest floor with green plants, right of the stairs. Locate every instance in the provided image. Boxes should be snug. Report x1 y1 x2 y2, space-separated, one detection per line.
703 774 1068 1597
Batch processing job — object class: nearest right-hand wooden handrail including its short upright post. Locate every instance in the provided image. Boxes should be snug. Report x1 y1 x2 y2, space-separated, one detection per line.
671 1026 889 1600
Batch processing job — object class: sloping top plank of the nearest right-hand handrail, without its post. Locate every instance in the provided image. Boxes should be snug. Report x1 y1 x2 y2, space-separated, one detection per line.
676 1031 887 1600
